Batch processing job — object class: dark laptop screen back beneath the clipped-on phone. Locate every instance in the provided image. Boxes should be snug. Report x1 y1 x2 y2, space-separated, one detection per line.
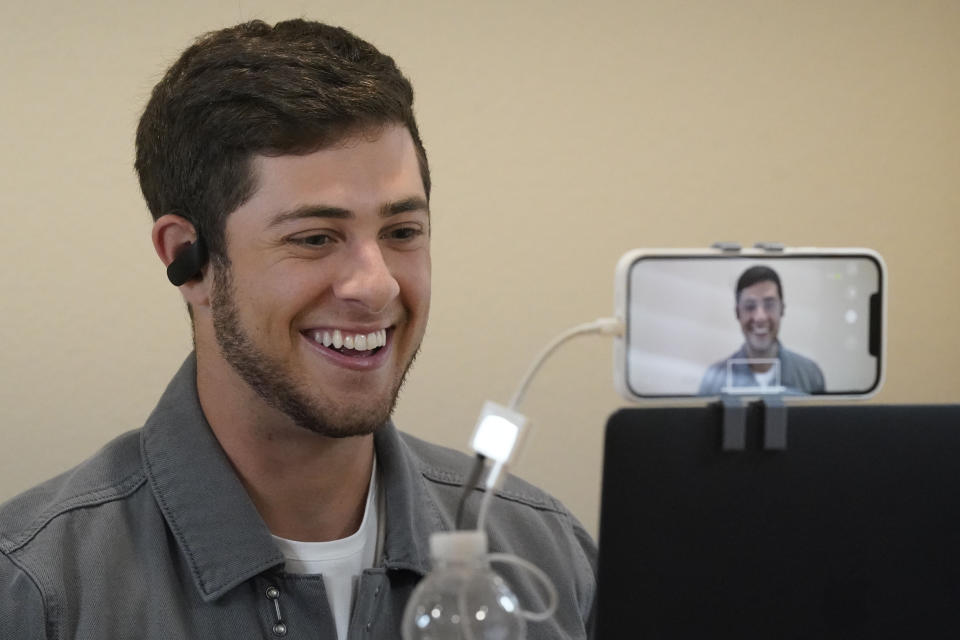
597 406 960 640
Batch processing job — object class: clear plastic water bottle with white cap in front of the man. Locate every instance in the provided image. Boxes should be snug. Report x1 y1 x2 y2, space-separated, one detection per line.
401 531 526 640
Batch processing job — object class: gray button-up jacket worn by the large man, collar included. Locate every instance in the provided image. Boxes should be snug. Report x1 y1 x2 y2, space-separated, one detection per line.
0 356 596 640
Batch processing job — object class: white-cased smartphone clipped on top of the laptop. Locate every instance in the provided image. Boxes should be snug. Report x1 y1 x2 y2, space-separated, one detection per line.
614 248 886 400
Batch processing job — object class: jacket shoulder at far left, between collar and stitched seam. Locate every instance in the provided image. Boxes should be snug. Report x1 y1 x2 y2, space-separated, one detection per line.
0 430 146 554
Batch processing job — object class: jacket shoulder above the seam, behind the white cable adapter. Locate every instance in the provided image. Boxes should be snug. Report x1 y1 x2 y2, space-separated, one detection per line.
400 432 569 515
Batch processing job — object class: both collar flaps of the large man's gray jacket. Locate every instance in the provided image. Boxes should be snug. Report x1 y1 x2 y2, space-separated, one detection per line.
141 354 436 601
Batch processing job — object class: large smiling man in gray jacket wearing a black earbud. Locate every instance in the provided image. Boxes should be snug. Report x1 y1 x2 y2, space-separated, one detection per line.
0 20 596 640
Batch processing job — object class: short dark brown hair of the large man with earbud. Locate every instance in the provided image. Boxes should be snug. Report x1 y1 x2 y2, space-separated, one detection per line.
135 20 430 259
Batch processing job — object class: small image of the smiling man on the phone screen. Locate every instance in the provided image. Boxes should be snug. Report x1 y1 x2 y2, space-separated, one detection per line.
699 266 825 395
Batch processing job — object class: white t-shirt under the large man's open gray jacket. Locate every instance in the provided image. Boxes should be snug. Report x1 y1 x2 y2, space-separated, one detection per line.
273 459 378 640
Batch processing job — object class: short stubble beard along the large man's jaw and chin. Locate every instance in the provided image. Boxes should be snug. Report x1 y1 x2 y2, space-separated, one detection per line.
210 265 419 438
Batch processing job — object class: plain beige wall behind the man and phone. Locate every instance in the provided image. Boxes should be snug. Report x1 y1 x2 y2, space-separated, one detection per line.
0 0 960 530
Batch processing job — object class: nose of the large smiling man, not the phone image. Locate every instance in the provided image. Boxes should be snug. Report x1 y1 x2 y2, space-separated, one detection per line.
334 241 400 313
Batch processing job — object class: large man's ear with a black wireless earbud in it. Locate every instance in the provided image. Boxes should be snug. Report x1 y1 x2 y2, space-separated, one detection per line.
151 213 209 306
